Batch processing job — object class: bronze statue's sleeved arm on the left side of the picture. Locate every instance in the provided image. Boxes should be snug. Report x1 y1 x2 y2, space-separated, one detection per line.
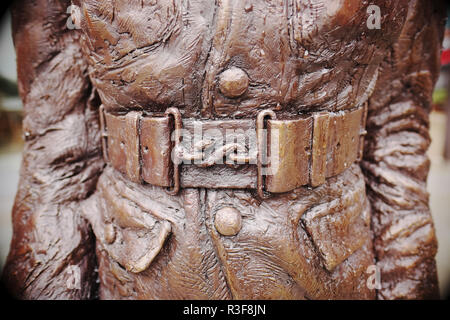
2 0 104 299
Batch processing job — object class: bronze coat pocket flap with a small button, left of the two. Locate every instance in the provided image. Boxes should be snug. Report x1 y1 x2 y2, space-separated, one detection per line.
88 179 172 273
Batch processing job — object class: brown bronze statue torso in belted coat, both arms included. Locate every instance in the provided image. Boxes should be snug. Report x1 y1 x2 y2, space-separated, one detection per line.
3 0 445 299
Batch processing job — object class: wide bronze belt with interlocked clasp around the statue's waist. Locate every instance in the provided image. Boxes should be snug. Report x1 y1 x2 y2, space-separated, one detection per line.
100 105 367 198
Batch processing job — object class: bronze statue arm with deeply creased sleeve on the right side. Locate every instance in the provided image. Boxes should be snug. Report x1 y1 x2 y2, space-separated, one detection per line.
362 0 446 299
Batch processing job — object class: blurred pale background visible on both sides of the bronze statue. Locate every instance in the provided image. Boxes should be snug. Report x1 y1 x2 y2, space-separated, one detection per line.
0 6 450 298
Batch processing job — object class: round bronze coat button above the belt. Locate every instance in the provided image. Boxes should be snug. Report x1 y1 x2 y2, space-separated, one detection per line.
219 67 249 98
